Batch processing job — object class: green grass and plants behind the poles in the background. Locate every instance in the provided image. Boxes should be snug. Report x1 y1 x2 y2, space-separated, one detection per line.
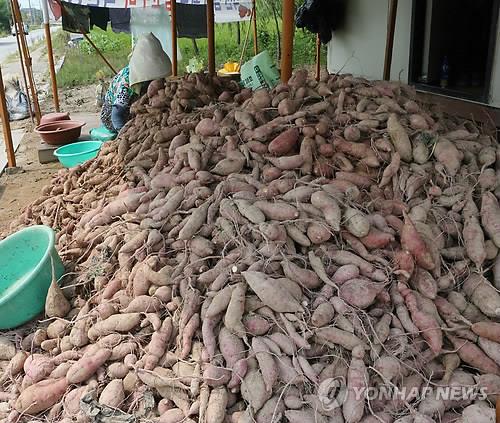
53 20 326 87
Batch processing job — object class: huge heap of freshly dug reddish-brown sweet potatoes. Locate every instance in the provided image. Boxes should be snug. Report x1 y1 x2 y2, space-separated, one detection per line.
0 70 500 423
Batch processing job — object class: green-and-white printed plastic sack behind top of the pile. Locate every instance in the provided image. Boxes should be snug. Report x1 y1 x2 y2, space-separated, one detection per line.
241 50 280 90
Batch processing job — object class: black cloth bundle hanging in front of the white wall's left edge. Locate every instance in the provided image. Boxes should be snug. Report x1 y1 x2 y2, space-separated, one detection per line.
295 0 346 44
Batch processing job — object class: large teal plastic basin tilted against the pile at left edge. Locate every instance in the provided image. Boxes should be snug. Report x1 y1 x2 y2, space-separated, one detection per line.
0 225 64 329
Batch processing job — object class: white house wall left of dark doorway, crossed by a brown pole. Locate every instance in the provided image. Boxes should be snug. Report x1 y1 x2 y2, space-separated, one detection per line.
328 0 412 82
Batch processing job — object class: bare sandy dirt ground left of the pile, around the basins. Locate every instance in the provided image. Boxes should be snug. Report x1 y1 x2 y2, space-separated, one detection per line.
0 86 97 234
